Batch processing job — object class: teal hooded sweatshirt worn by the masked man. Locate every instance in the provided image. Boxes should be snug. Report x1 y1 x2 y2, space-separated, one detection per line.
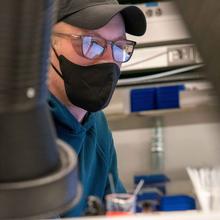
48 94 125 217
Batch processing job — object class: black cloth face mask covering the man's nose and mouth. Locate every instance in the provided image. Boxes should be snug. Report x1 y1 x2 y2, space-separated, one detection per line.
51 50 120 112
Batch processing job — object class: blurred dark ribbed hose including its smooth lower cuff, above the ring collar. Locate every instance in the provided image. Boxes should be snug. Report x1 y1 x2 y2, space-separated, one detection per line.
0 0 59 182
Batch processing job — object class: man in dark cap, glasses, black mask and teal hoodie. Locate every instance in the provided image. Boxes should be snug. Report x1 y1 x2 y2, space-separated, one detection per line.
48 0 146 217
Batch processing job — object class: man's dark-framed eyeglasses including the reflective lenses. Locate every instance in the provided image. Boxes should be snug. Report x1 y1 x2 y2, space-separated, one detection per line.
53 32 136 63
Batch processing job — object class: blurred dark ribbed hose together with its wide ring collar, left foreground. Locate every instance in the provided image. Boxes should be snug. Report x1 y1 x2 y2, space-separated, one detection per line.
0 0 78 219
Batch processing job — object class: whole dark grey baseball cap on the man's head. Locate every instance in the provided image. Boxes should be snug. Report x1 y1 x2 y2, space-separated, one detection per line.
57 0 147 36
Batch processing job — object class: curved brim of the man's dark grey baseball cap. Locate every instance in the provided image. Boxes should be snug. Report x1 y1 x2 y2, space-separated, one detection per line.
62 5 147 36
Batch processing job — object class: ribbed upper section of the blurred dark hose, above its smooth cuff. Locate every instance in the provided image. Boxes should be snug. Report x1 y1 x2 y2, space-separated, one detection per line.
0 0 53 112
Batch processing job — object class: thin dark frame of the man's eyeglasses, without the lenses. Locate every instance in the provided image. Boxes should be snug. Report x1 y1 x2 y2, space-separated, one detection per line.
53 32 137 63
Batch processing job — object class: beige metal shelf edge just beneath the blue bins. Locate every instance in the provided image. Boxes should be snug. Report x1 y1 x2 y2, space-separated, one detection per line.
106 105 220 131
